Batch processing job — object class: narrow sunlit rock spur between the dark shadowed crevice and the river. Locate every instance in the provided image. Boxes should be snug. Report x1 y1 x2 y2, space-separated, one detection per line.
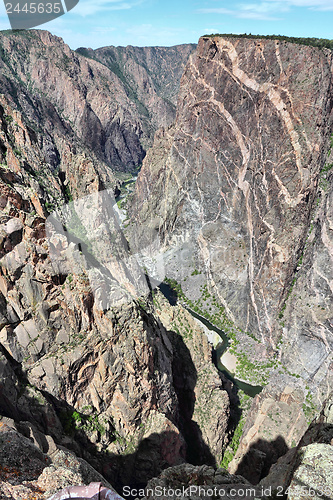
154 292 230 465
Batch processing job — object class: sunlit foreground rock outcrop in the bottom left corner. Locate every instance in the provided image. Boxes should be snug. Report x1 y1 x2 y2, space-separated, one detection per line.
0 418 111 500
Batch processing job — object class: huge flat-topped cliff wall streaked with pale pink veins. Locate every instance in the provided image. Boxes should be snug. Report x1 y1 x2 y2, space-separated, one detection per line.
131 37 333 392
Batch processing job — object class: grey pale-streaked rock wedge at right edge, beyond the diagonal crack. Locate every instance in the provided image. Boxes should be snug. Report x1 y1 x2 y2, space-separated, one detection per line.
279 133 333 402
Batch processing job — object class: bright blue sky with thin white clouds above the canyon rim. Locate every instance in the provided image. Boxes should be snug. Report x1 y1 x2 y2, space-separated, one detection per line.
0 0 333 49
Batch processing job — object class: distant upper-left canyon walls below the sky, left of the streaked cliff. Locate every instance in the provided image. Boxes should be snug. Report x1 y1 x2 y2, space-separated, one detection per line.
0 30 194 171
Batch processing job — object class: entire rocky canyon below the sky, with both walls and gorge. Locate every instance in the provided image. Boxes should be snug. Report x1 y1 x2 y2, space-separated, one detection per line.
0 30 333 500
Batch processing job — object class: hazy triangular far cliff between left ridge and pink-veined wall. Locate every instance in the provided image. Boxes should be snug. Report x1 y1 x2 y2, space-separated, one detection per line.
76 44 196 146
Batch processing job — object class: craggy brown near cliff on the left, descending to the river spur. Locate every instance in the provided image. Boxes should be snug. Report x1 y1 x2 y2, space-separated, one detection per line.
0 96 229 487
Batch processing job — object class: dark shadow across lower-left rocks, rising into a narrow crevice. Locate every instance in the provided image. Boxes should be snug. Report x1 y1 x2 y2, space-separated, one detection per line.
0 316 215 492
